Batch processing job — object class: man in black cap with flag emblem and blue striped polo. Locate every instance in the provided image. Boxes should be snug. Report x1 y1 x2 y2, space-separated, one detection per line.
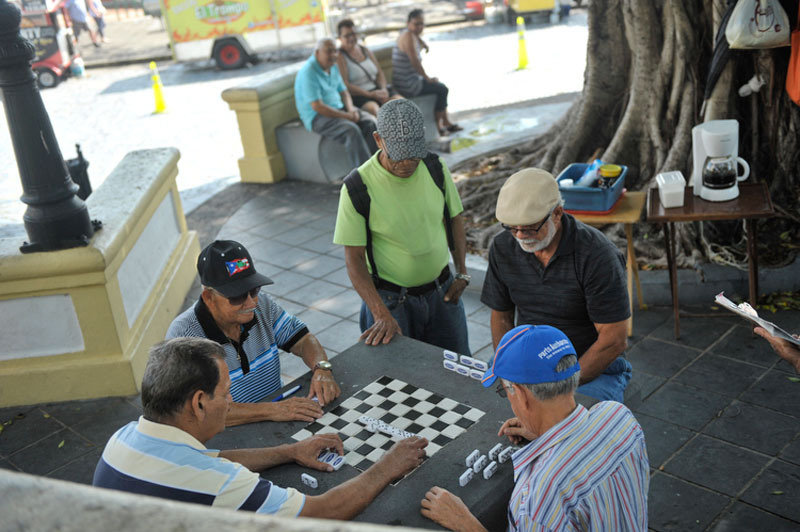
167 240 340 426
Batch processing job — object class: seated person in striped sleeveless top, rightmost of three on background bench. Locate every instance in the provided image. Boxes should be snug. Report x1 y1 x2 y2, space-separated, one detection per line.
392 9 463 135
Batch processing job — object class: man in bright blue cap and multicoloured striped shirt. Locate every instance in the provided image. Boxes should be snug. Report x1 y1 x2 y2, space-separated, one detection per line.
421 325 650 532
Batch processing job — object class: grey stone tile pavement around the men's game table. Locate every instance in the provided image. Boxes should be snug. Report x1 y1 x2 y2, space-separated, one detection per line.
0 182 800 532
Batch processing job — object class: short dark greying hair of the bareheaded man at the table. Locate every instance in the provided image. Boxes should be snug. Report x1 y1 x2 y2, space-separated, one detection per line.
142 338 225 422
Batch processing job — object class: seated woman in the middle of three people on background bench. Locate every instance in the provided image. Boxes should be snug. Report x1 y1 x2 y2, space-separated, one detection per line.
336 18 402 116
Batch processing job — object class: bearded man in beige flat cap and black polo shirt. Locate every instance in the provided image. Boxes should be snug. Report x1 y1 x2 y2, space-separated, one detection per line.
481 168 631 402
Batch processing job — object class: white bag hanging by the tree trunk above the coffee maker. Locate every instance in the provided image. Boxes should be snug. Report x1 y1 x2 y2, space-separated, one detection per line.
725 0 791 50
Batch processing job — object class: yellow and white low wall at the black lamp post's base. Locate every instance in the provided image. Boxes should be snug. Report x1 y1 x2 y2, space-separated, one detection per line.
0 148 200 406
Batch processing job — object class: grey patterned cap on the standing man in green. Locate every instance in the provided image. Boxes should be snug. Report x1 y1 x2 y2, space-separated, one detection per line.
378 100 428 161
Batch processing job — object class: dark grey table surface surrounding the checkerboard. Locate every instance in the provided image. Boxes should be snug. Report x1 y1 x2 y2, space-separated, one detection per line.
208 336 594 530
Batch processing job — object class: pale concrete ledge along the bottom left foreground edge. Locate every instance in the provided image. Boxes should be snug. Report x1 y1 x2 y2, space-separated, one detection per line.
0 469 420 532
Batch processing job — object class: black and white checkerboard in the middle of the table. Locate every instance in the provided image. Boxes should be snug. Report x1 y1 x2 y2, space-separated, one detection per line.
292 376 484 471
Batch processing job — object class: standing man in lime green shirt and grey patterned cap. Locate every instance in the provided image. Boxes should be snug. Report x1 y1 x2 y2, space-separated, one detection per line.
333 100 470 355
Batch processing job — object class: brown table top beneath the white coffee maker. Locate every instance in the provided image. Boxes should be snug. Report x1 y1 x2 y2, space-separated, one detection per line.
647 183 775 223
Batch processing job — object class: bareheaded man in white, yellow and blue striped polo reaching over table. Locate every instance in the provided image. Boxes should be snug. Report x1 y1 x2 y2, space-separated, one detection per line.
92 338 427 519
